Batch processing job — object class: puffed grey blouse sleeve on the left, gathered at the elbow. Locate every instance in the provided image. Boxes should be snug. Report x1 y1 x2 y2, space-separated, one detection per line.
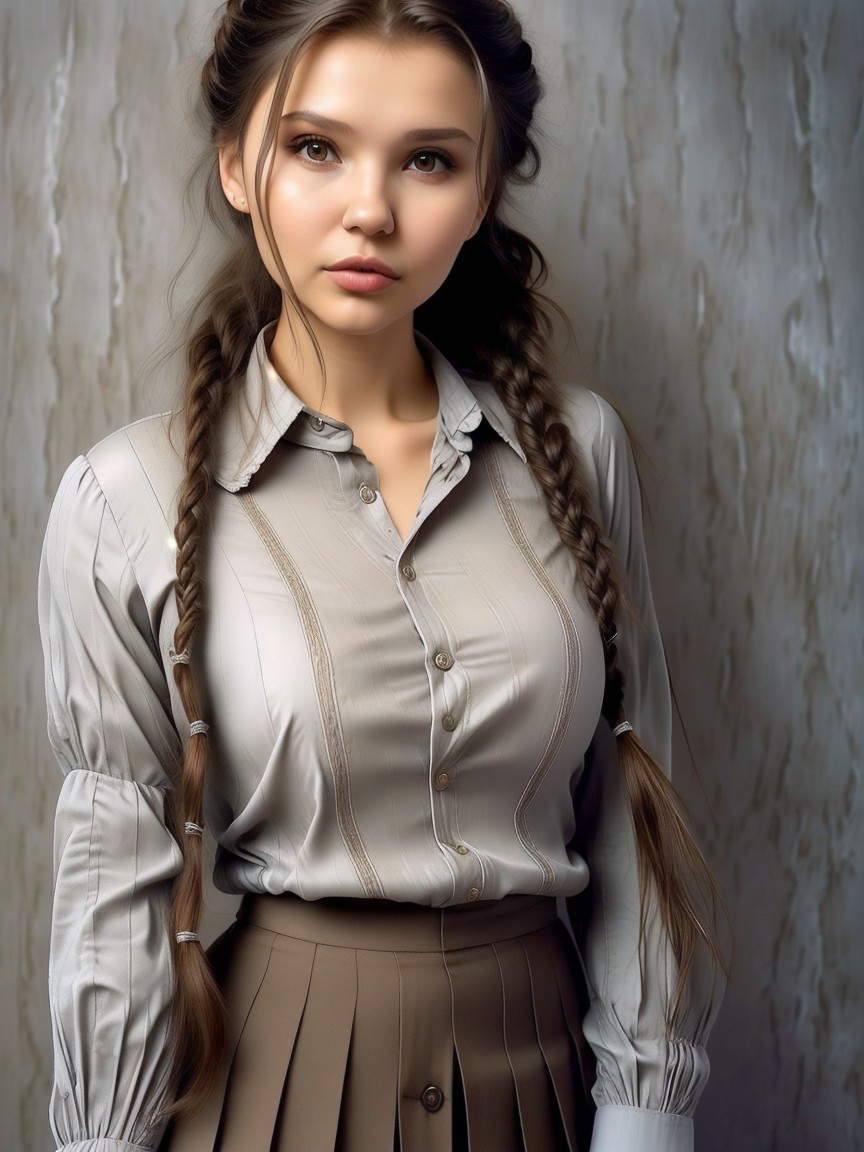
39 457 181 1152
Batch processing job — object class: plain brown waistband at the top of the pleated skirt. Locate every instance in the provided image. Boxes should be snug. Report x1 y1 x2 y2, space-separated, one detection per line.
237 893 558 952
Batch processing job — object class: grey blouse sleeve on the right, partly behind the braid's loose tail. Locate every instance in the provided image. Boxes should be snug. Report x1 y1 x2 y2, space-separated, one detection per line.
571 394 720 1152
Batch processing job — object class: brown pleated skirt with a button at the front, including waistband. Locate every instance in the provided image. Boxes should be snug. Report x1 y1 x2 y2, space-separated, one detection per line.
162 895 593 1152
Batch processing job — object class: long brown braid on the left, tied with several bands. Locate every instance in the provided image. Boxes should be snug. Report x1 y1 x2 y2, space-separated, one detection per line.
167 241 281 1114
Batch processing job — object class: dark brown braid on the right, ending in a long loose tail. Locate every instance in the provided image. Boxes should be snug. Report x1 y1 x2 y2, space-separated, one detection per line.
463 221 725 1033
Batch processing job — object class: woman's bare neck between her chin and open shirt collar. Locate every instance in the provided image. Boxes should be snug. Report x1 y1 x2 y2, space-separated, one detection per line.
270 311 438 427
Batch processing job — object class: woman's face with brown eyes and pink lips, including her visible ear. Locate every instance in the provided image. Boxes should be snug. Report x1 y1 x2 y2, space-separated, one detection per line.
220 36 485 336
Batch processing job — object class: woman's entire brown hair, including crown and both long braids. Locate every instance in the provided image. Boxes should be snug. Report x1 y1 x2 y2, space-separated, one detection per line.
169 0 723 1112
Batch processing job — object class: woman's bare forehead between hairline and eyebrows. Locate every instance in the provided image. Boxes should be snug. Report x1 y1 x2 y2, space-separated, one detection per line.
274 36 483 139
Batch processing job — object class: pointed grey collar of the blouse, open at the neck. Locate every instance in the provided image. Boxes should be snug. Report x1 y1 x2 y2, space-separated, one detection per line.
214 325 525 492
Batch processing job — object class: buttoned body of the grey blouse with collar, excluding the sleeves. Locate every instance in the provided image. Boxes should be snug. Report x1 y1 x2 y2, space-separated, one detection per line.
89 331 604 905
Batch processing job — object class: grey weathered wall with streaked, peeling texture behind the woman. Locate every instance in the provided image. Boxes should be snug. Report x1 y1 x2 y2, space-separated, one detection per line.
0 0 864 1152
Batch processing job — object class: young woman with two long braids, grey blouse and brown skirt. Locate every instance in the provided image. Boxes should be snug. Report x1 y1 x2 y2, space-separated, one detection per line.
40 0 718 1152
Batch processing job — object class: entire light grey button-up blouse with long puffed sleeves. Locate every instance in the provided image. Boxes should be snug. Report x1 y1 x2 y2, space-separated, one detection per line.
39 329 717 1152
